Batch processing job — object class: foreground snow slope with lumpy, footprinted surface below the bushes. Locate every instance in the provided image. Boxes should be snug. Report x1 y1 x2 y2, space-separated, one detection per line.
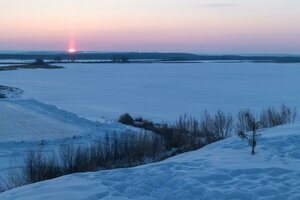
0 124 300 200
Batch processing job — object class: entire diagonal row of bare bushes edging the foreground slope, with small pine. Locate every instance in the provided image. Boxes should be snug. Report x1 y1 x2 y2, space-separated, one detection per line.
4 105 296 189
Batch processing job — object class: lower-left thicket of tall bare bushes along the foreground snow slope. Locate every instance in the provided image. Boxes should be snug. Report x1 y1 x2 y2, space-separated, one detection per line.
2 132 166 189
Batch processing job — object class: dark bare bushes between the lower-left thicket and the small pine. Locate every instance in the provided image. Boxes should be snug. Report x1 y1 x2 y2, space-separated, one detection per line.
119 110 233 152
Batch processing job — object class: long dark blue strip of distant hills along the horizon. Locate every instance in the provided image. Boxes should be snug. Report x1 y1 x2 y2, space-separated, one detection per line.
0 52 300 63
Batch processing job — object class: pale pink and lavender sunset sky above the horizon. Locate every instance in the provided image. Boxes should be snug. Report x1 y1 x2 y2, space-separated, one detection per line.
0 0 300 54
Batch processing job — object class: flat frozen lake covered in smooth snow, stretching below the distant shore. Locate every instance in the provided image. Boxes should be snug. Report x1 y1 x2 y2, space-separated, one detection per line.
0 63 300 121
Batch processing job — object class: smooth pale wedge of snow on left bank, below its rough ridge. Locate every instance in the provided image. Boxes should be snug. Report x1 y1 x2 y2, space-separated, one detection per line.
0 101 86 142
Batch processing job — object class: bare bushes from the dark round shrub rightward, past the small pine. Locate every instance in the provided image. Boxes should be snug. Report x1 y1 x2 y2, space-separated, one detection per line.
119 104 296 152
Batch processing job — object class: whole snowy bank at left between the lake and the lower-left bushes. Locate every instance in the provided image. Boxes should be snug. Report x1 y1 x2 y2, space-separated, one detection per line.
0 99 125 180
